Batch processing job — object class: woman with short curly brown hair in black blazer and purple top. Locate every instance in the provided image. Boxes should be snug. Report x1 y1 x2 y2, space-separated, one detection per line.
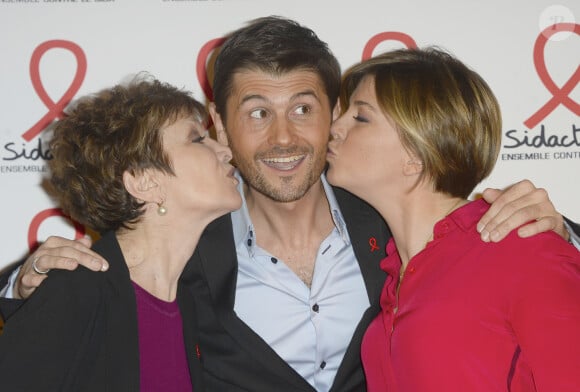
0 76 241 392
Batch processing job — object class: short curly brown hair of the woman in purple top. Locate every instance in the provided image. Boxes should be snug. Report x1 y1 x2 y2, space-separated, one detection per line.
48 74 207 233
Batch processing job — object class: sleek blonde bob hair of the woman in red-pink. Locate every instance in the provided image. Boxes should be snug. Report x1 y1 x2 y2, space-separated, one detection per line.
341 47 501 198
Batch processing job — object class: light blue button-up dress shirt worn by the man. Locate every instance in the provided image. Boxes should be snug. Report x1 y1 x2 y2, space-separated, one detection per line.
232 176 370 391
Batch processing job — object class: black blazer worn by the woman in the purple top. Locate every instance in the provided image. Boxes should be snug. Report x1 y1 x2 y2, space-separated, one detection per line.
0 233 204 392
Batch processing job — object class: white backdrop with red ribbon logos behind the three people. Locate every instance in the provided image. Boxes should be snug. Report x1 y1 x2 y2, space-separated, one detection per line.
0 0 580 269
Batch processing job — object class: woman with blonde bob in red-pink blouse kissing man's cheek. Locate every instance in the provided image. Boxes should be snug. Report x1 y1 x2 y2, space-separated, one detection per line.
328 48 580 392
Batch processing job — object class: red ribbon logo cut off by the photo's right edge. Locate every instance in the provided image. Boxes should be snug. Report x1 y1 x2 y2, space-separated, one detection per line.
524 23 580 129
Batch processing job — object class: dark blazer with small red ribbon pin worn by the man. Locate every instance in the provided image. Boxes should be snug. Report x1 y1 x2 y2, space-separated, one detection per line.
182 189 390 392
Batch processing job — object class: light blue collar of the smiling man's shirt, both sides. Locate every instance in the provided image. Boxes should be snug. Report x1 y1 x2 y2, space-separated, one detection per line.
232 170 350 255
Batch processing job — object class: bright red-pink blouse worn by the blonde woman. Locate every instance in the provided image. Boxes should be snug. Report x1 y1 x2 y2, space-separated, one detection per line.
362 200 580 392
